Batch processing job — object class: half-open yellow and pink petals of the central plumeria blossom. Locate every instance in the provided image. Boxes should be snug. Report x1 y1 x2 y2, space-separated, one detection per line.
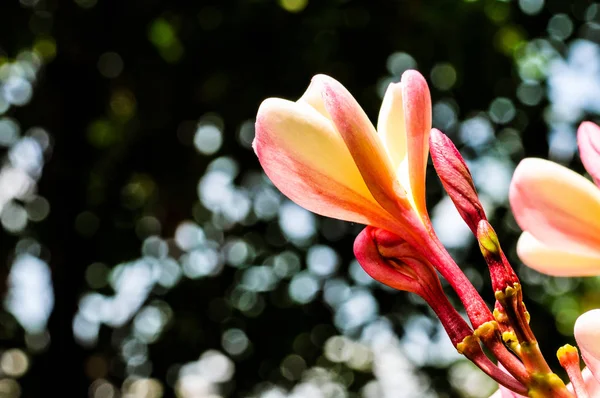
254 71 431 241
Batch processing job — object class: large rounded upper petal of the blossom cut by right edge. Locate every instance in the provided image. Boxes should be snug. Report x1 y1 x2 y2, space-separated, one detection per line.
509 158 600 252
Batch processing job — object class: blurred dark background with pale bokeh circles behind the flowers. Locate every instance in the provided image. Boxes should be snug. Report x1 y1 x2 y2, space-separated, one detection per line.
0 0 600 398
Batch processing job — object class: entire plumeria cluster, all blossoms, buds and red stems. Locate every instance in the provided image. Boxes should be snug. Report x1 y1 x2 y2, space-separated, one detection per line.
254 71 600 398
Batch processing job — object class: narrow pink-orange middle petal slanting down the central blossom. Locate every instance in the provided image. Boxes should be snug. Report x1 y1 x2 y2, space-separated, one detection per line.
313 75 412 219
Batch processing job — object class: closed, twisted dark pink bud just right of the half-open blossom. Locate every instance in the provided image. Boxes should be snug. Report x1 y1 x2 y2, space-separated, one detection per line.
429 129 486 234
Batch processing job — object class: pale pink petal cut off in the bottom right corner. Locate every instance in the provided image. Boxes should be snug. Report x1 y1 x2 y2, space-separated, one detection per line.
575 309 600 383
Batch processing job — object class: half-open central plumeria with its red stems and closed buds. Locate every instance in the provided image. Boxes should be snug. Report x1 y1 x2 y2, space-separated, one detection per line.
253 71 596 398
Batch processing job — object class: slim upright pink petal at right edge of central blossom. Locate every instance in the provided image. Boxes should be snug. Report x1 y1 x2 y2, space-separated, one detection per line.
401 70 431 214
